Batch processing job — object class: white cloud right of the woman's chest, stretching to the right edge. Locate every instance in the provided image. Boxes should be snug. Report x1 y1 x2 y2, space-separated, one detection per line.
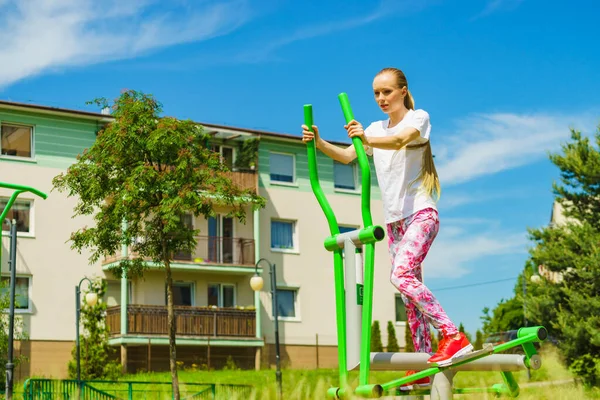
435 113 597 187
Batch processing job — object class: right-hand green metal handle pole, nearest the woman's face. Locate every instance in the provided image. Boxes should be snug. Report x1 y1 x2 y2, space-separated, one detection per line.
338 93 375 386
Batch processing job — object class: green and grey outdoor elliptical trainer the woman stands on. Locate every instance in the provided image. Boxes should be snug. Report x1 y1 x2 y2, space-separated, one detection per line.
304 93 547 400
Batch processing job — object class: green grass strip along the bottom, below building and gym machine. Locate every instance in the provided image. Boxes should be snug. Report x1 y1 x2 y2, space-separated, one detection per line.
11 347 600 400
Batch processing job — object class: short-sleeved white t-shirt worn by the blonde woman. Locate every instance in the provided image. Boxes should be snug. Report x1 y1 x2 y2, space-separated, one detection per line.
365 110 437 224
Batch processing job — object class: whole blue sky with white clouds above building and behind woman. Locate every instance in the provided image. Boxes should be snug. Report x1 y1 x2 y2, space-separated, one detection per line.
0 0 600 332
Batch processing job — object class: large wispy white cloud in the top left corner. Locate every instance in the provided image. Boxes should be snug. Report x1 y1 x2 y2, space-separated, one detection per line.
0 0 251 88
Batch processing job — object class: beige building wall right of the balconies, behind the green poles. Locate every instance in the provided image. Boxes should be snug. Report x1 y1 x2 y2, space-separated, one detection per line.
255 186 405 346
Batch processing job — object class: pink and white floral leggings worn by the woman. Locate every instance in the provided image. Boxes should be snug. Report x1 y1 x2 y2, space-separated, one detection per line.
387 208 458 353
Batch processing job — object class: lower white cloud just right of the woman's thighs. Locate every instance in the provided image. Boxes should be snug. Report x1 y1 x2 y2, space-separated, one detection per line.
424 218 528 279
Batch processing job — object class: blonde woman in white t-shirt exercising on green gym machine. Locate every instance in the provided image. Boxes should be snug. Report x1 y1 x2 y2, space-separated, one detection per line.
302 68 473 388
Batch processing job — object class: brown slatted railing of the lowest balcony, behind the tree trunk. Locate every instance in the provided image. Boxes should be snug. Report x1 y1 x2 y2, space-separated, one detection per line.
106 304 256 338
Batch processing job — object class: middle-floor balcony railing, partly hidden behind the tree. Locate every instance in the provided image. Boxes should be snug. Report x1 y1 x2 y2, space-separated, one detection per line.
104 236 255 266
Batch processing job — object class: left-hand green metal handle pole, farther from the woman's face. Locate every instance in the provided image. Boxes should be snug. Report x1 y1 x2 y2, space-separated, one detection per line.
304 104 348 390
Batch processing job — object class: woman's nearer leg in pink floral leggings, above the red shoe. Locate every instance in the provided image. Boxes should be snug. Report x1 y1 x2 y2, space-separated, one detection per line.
390 209 458 338
